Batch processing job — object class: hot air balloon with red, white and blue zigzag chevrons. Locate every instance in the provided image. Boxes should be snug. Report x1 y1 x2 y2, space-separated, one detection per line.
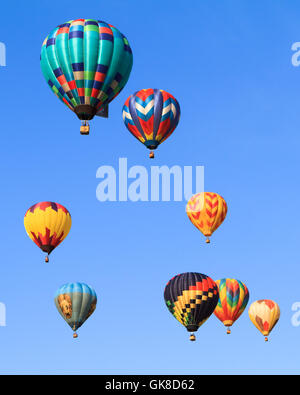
123 89 180 158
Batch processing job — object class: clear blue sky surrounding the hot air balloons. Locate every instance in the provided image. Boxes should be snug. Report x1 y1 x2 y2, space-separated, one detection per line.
0 0 300 374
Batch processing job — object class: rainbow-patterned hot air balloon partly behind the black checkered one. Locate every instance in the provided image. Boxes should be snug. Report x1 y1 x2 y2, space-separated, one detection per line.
214 278 249 334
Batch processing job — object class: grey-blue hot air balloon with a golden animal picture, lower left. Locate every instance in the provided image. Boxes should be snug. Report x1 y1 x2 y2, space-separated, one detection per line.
54 283 97 339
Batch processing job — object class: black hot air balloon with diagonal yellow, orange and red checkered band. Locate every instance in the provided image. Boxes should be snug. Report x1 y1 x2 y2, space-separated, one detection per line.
164 273 219 341
